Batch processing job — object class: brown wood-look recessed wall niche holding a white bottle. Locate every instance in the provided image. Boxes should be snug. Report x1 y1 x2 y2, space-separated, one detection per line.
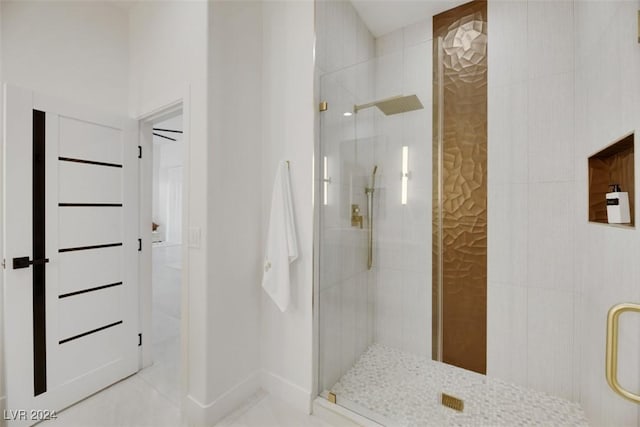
589 133 635 227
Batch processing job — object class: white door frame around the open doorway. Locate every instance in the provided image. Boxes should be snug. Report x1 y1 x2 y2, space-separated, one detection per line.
136 85 191 399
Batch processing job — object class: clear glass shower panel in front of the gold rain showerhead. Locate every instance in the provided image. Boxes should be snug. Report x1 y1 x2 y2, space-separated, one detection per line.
316 37 431 425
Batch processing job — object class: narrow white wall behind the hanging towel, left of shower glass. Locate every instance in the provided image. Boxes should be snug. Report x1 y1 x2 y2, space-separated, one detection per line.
257 1 316 411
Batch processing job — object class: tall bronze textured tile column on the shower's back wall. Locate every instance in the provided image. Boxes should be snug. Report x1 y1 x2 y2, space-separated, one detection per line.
432 1 487 373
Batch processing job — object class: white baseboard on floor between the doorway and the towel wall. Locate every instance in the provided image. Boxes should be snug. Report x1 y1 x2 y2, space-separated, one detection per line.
184 371 261 427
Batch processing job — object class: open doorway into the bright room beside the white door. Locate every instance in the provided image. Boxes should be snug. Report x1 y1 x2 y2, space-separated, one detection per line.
139 108 186 406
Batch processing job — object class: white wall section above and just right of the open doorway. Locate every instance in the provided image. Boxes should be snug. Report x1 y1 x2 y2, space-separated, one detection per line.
129 1 210 422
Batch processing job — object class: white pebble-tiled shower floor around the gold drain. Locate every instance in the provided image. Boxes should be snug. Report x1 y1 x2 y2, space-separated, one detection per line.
331 344 589 427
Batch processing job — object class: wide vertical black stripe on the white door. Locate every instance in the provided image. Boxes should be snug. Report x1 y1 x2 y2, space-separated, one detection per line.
33 110 47 396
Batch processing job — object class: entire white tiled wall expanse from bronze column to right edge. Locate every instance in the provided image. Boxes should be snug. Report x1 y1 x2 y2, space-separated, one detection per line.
488 1 640 426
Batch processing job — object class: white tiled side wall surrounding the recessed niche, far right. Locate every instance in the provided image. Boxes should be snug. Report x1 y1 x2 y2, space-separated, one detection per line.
570 0 640 426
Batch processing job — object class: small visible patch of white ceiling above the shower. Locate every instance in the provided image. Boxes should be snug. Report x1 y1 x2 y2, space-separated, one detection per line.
351 0 470 38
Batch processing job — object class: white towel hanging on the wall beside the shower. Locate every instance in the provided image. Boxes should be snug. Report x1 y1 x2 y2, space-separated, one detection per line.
262 161 298 311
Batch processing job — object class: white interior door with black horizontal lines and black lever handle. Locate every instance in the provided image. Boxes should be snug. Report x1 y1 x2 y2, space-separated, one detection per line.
4 86 138 426
